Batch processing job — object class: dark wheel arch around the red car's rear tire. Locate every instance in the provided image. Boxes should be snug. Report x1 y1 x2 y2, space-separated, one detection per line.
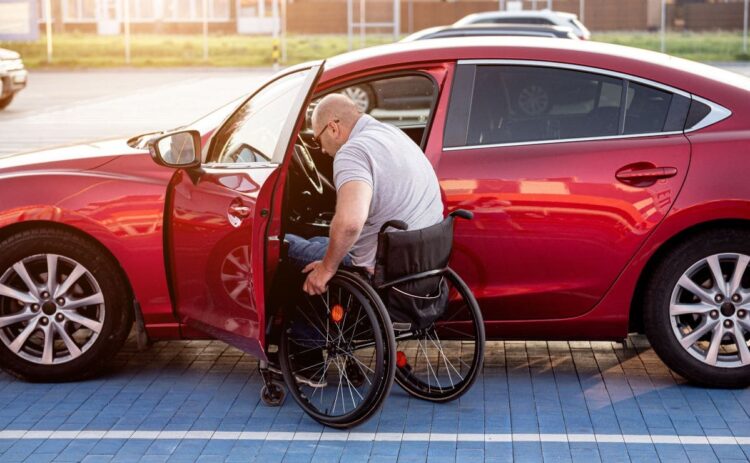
628 219 750 333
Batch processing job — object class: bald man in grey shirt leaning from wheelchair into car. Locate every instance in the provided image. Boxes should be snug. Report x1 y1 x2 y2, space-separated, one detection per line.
288 94 443 295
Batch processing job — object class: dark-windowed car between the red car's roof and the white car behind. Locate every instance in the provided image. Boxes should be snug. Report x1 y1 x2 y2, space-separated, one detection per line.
401 23 578 42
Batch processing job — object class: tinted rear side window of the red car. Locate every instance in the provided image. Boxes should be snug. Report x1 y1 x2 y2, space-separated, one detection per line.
444 65 690 147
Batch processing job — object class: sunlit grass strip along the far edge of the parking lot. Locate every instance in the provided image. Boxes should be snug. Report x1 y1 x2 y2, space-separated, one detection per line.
0 32 750 69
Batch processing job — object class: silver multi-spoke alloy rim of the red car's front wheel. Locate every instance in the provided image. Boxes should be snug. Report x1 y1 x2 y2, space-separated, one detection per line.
0 254 105 365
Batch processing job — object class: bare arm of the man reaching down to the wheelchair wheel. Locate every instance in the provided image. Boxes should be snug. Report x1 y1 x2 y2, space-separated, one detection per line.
302 180 372 294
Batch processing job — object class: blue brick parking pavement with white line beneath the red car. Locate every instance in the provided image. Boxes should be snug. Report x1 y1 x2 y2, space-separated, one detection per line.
0 337 750 463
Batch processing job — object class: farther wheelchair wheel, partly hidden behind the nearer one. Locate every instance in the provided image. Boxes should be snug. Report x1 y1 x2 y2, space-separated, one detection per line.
395 269 485 402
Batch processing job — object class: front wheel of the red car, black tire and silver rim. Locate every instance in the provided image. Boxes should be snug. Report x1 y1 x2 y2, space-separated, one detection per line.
0 228 133 382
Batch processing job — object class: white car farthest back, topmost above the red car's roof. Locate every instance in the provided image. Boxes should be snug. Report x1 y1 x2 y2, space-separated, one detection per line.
453 10 591 40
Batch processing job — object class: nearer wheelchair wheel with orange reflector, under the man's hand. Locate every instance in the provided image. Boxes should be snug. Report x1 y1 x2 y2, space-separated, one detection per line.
279 271 396 428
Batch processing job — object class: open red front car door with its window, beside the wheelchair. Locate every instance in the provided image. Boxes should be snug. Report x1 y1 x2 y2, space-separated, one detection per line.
165 63 323 359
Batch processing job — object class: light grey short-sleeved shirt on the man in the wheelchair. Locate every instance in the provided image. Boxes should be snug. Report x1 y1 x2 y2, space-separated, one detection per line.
333 114 443 267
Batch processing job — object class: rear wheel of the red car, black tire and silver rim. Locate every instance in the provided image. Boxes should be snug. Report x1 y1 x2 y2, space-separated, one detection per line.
643 229 750 388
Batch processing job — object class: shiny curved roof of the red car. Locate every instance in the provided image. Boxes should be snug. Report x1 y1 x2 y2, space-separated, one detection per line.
321 36 750 103
